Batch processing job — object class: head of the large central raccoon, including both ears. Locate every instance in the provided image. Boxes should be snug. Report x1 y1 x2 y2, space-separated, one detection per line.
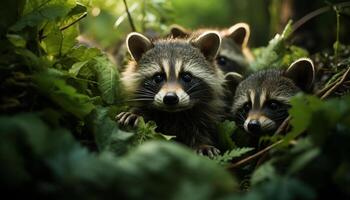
123 32 223 112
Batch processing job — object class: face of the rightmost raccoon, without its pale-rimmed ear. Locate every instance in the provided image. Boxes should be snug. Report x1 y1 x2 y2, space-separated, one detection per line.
234 70 299 134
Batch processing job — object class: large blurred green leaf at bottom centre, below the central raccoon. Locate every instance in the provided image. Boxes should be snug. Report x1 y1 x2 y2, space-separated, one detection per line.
120 141 237 199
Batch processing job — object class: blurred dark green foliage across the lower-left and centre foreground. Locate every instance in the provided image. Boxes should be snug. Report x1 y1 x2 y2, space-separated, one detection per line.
0 114 235 199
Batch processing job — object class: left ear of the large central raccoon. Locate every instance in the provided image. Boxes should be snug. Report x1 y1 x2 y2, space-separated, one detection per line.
126 32 154 62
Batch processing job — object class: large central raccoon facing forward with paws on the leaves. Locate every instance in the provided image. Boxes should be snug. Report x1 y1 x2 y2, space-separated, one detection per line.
117 32 224 156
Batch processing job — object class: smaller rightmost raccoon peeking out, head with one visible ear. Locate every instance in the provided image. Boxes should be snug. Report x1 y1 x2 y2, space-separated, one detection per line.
232 58 315 136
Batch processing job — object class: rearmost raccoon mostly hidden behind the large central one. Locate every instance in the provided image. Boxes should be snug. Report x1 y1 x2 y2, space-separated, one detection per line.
170 23 253 75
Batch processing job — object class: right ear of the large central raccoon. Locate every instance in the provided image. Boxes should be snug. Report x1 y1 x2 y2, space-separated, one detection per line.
191 31 221 61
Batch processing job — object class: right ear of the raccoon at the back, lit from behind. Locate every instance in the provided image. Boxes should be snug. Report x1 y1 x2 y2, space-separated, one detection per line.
223 23 250 48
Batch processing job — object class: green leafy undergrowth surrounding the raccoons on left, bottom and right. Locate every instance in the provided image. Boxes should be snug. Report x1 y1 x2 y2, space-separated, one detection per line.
0 0 350 200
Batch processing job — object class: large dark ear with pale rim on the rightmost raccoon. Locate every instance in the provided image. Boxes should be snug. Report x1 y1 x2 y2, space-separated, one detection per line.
284 58 315 91
